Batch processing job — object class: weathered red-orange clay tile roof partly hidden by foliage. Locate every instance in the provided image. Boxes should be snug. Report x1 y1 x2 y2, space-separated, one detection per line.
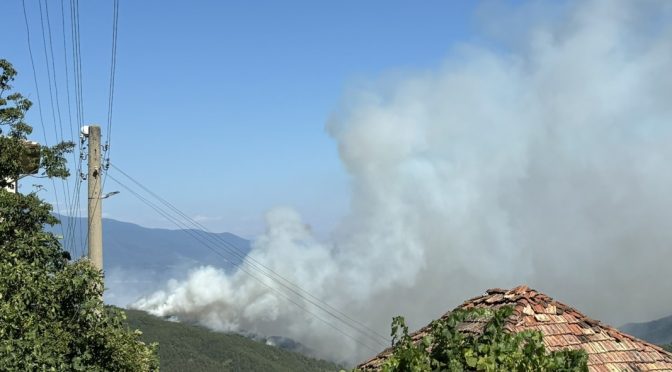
358 286 672 372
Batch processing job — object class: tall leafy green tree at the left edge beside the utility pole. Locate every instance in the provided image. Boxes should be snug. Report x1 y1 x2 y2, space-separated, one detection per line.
0 59 158 371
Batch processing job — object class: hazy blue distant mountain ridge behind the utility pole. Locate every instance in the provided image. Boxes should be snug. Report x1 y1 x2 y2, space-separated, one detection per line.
51 216 250 307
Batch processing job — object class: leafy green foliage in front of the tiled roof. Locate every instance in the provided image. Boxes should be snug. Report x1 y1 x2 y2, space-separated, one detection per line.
382 307 588 372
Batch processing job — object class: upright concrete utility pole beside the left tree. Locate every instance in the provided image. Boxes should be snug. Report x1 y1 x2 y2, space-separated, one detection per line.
82 125 103 270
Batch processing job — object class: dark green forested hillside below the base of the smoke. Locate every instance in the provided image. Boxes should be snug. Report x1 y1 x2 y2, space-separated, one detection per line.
126 310 339 372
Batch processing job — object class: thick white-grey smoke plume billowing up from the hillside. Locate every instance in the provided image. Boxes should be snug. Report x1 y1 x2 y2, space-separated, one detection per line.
135 1 672 362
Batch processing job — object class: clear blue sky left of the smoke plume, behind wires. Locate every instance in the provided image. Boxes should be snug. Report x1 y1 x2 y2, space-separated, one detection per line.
0 0 484 236
